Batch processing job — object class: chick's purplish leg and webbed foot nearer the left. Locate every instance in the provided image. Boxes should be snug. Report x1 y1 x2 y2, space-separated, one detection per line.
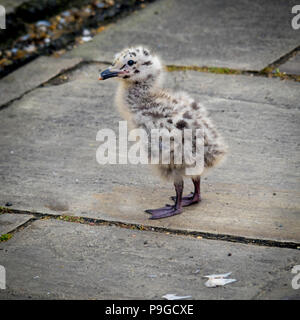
145 180 183 219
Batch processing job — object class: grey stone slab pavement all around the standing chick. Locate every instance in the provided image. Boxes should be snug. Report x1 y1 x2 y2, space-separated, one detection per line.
0 0 300 299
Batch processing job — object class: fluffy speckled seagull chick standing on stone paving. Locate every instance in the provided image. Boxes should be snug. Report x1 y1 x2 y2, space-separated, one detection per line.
99 46 227 219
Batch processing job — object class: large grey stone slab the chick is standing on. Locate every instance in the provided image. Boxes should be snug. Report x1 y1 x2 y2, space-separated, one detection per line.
0 65 300 243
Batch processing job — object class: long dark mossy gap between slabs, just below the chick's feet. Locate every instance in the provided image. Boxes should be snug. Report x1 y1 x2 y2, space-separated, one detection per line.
2 209 300 250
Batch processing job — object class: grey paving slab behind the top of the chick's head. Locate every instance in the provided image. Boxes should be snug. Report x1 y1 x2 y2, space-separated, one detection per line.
68 0 300 70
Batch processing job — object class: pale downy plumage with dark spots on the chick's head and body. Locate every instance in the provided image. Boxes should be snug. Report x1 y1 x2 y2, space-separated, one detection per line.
113 47 227 180
